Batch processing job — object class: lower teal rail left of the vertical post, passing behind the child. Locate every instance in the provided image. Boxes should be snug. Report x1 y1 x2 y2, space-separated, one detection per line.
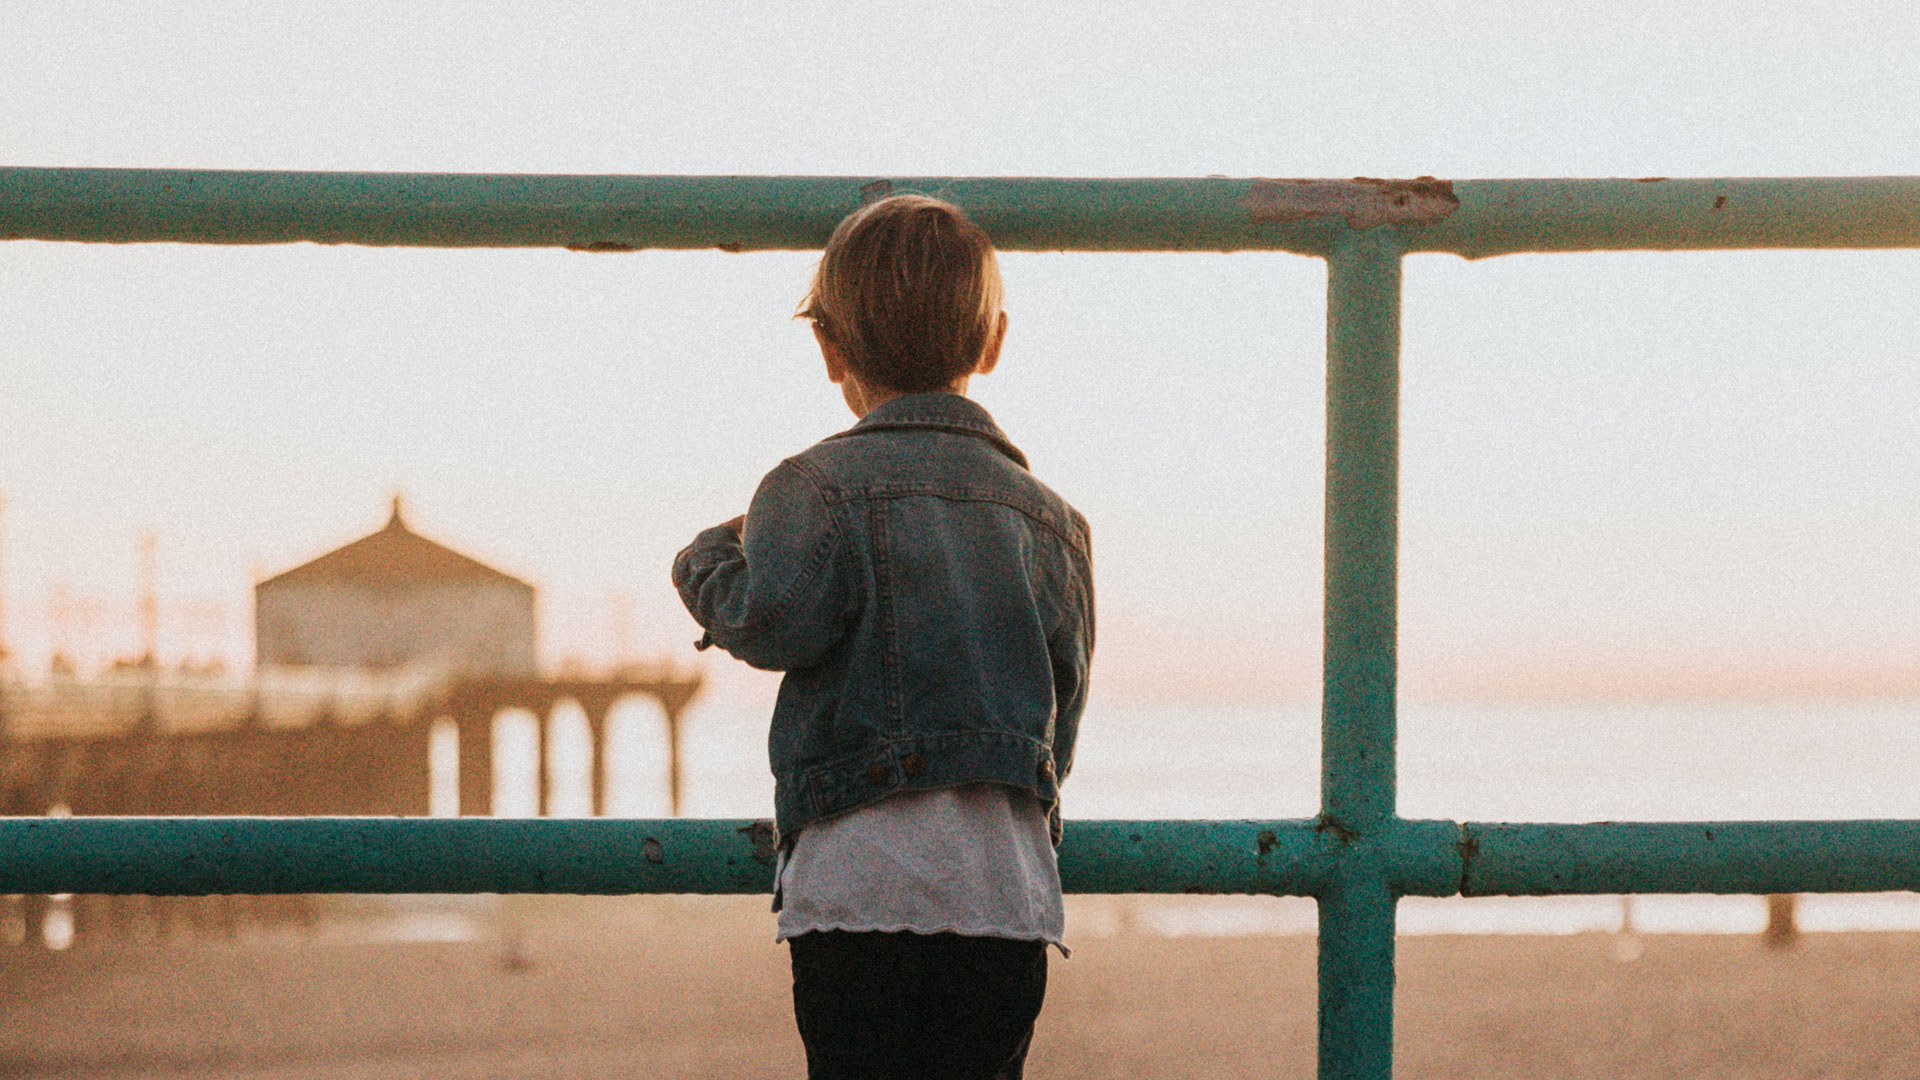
0 817 1332 896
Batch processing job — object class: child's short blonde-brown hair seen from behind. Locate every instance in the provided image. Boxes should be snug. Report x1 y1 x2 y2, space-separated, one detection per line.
797 194 1002 394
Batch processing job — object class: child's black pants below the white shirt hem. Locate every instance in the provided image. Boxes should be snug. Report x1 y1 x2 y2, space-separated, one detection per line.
787 930 1046 1080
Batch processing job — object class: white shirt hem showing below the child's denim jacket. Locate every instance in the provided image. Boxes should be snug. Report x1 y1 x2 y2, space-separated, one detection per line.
778 784 1068 955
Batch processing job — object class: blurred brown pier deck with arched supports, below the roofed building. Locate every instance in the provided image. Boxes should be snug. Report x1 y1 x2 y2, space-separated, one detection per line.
0 665 703 945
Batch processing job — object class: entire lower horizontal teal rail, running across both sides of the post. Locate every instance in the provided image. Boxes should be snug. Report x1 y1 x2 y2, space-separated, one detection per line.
15 817 1920 896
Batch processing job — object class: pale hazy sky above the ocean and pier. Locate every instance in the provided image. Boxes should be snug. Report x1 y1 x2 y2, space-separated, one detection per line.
0 0 1920 698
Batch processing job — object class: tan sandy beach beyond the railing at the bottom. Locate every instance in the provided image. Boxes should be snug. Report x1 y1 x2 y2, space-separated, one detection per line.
0 897 1920 1080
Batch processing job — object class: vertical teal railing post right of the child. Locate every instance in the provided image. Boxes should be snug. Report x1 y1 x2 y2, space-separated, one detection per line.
1319 229 1402 1080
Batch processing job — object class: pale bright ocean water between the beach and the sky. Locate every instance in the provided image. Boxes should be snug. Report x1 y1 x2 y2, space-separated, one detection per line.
568 701 1920 936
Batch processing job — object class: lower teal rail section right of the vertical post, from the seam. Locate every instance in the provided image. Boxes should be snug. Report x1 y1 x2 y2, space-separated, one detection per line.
1459 821 1920 896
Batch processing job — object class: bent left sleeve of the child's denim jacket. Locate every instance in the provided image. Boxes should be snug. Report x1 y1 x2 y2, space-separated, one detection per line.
674 461 856 671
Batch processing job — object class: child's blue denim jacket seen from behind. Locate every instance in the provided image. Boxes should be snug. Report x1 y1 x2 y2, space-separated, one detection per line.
674 394 1094 844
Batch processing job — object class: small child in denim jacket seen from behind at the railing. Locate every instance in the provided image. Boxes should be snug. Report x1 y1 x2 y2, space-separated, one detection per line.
674 194 1092 1080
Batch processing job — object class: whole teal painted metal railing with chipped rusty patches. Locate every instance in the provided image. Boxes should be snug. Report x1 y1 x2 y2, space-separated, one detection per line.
0 169 1920 1080
